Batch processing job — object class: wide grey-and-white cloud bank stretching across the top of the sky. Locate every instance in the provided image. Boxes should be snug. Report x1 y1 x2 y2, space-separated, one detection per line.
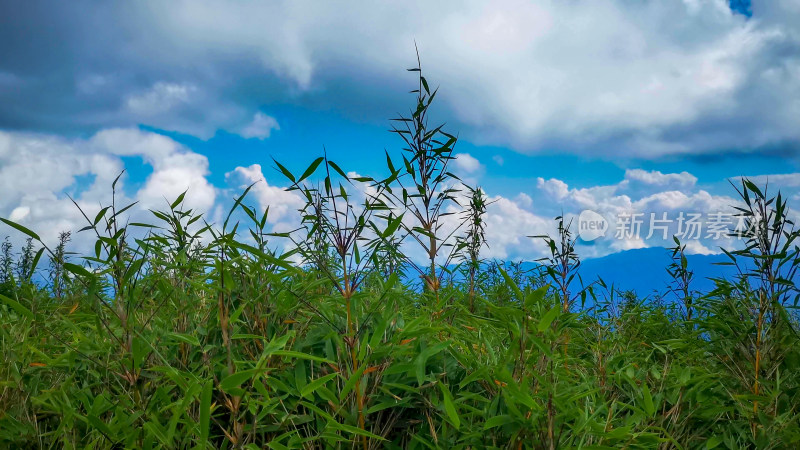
0 0 800 158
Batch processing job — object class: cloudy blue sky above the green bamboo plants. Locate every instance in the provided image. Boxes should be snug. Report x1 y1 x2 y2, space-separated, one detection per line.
0 0 800 260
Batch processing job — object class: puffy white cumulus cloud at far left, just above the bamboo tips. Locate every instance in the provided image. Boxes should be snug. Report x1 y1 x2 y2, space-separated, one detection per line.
0 129 216 248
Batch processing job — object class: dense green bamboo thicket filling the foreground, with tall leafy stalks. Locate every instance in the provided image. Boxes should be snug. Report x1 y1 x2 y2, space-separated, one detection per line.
0 68 800 449
